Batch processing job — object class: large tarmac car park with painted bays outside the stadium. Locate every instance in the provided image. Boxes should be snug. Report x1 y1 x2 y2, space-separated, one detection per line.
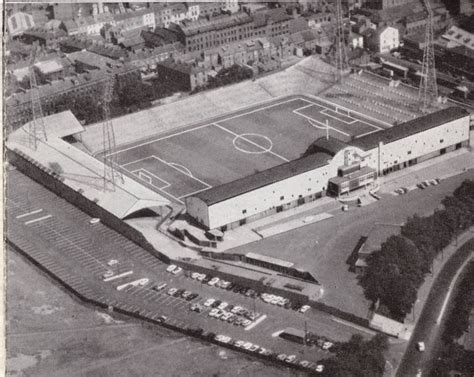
7 171 373 368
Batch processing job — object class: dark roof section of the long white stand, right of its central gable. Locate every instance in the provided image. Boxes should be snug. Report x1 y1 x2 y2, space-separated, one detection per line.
350 106 469 151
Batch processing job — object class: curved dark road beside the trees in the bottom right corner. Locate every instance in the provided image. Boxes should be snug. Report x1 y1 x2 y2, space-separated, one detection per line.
397 232 474 377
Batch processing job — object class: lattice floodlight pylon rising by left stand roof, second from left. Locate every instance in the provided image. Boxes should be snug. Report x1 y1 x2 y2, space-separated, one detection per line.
102 74 123 191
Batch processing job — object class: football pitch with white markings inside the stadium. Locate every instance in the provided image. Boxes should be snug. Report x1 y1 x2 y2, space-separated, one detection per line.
109 96 387 203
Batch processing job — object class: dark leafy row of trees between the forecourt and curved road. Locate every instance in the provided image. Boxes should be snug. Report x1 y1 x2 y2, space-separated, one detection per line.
360 180 474 321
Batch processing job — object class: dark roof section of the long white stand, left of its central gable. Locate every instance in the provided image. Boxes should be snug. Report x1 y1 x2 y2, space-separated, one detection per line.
193 153 330 206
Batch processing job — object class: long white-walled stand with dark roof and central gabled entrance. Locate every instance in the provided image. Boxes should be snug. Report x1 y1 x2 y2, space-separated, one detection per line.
185 107 470 231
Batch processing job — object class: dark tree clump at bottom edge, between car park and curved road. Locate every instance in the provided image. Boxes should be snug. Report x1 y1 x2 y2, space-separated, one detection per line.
321 334 388 377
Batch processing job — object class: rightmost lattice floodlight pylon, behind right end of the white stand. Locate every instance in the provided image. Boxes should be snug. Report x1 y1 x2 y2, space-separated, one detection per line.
418 0 438 112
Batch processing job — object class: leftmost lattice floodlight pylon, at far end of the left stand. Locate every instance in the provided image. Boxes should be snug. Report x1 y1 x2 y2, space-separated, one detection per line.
28 43 48 150
